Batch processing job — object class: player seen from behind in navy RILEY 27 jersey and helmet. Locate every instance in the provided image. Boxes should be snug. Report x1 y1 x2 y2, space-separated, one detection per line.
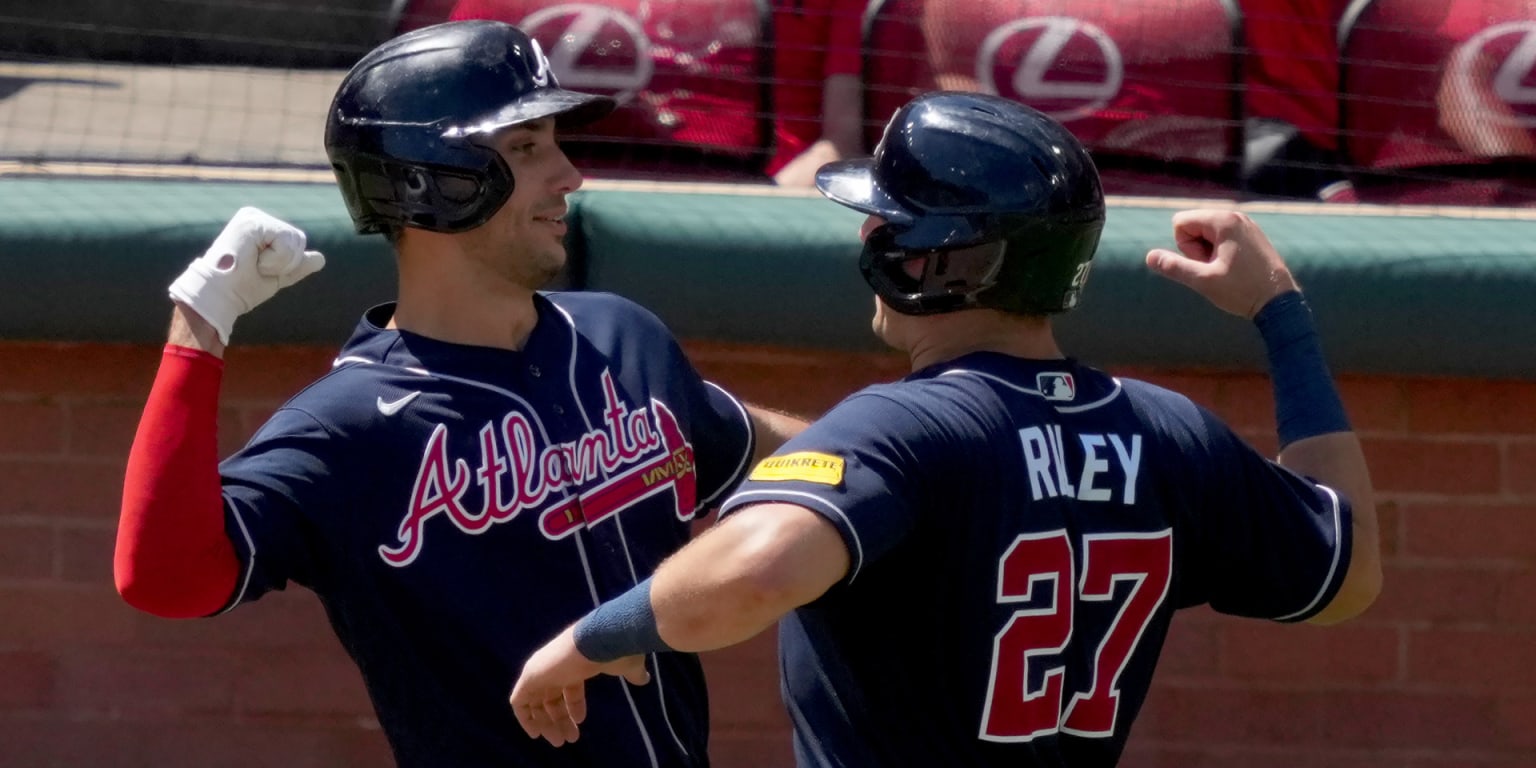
511 92 1381 768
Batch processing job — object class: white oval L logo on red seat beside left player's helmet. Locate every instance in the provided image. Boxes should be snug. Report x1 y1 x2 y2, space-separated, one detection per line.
518 3 656 103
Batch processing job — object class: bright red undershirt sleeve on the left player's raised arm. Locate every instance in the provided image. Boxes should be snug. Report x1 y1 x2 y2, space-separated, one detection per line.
112 344 240 619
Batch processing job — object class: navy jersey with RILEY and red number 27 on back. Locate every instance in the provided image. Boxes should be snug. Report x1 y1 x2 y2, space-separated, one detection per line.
722 353 1350 768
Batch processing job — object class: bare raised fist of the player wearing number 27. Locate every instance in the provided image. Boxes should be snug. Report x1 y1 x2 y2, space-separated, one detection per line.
1147 209 1296 318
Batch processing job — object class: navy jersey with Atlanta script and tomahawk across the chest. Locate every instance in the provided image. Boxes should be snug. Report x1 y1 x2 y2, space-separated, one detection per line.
221 293 754 766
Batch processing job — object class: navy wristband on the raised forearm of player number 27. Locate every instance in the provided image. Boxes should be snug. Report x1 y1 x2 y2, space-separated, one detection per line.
1253 290 1350 449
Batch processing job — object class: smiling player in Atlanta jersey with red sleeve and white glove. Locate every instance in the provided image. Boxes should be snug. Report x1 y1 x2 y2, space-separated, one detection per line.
115 22 800 768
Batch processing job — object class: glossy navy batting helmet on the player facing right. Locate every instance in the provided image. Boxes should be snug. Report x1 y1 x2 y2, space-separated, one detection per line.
326 20 614 233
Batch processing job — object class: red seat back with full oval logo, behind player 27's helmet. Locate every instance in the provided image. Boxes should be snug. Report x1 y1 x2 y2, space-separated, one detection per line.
869 0 1241 169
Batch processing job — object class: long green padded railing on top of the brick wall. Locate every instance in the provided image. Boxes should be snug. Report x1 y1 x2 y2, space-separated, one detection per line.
9 178 1536 378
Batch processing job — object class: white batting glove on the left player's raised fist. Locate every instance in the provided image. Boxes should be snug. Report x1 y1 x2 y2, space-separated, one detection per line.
170 206 326 344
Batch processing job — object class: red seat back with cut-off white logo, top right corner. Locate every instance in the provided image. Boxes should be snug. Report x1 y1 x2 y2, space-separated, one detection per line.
1339 0 1536 206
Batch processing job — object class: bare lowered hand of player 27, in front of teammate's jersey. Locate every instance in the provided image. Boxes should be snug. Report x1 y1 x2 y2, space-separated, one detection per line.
510 625 651 746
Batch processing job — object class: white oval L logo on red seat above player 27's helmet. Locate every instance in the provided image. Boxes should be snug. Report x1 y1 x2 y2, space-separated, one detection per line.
975 15 1126 121
